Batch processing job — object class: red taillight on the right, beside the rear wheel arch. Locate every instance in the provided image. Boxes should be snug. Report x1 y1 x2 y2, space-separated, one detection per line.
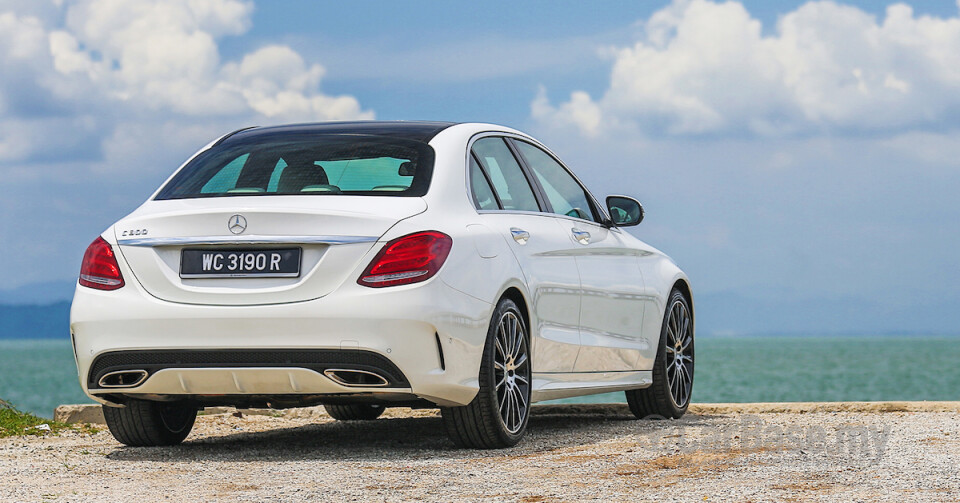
357 231 453 288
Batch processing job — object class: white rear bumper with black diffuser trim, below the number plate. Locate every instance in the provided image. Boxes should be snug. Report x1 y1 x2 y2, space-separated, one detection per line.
70 278 493 405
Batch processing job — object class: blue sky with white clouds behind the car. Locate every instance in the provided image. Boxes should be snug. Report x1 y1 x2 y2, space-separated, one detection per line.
0 0 960 333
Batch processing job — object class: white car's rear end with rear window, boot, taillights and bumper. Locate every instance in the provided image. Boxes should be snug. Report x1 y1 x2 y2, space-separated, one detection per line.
71 126 490 407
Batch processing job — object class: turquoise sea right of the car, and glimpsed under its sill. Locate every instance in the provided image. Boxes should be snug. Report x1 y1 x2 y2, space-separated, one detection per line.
544 336 960 403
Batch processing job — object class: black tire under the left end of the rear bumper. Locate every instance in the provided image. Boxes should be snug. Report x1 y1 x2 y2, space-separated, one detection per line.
103 399 197 447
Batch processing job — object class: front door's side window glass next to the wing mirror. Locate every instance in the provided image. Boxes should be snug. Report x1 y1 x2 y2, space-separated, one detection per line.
514 141 599 222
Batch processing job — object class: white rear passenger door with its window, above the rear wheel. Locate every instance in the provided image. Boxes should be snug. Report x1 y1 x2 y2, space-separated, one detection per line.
469 136 580 373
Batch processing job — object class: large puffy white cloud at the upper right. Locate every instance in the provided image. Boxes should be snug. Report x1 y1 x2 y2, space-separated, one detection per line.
531 0 960 136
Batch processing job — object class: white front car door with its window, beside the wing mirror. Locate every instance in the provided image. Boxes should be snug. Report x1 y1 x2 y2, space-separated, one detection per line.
512 140 650 372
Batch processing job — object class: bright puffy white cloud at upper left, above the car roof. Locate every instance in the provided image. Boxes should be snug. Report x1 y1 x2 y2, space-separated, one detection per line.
37 0 372 120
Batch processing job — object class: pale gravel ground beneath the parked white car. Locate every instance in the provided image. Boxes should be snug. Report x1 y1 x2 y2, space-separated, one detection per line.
0 406 960 502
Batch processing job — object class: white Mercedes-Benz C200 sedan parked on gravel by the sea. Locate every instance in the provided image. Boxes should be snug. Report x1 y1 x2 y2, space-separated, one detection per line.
70 121 694 448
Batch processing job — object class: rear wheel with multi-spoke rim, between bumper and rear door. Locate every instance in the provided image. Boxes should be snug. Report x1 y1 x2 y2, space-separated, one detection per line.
440 299 531 449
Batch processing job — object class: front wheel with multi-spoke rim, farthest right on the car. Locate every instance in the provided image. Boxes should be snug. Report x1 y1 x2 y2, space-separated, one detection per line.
626 289 694 419
